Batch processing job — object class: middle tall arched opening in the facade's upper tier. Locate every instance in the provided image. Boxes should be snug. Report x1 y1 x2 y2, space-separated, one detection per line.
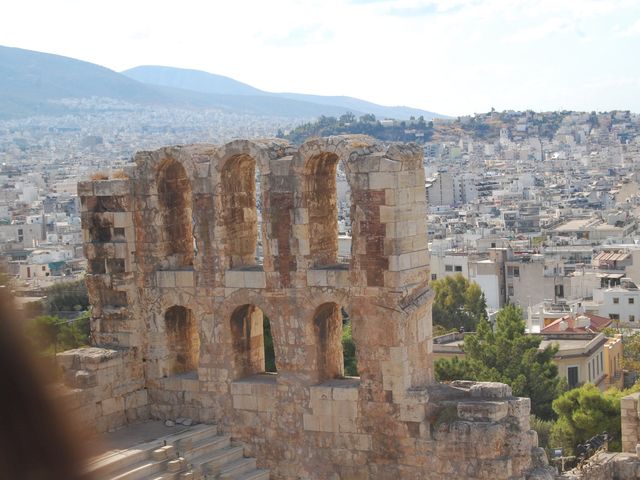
221 155 262 269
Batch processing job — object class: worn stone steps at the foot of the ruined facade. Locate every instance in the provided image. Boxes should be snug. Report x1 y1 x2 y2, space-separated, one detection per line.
87 425 269 480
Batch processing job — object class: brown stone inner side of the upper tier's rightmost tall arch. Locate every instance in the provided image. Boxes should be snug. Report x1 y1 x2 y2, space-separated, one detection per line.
305 152 339 267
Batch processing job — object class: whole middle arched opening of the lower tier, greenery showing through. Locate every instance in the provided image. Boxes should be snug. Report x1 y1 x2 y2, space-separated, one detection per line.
231 305 276 377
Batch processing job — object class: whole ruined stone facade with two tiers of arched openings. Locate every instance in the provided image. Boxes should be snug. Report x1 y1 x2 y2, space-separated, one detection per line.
65 136 550 479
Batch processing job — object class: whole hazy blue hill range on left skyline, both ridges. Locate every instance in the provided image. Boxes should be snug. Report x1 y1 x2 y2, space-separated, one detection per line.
0 46 448 119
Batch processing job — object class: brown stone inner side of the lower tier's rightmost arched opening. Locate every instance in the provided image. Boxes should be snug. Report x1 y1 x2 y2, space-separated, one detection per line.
313 302 344 382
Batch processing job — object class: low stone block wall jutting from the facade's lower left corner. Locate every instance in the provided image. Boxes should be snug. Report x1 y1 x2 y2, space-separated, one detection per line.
57 347 149 432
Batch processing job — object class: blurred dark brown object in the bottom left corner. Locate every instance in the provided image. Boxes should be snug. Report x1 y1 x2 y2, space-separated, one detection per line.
0 289 90 480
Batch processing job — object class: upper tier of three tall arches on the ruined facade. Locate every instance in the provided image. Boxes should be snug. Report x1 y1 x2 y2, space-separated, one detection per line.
104 135 426 287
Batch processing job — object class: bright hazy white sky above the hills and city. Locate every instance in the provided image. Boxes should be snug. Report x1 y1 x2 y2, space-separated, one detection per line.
0 0 640 115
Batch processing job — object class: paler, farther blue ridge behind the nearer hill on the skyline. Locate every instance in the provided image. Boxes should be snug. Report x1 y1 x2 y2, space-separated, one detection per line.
122 65 444 120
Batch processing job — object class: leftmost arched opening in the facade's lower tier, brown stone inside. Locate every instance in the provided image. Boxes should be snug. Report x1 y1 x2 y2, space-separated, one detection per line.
164 305 200 374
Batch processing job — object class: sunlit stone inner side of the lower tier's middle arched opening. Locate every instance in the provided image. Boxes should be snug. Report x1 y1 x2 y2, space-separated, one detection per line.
230 304 276 378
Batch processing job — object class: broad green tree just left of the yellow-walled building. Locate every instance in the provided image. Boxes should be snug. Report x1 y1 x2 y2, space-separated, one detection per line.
435 305 564 420
